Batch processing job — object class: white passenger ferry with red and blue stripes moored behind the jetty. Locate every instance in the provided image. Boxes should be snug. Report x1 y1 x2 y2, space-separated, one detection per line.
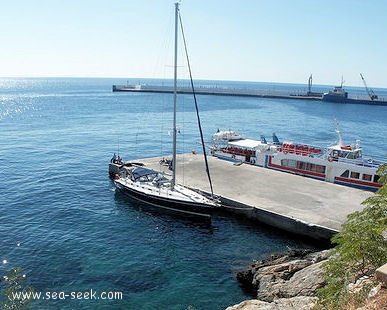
210 130 383 191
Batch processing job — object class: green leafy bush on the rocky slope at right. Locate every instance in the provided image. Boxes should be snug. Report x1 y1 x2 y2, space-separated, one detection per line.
318 164 387 309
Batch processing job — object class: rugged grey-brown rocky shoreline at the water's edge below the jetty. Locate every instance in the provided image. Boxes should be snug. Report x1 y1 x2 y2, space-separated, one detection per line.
226 250 331 310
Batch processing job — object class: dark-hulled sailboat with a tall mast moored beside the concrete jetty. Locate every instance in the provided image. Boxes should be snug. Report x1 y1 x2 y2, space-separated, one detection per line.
109 3 218 218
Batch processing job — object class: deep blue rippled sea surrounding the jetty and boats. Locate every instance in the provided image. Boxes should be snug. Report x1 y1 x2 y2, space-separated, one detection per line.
0 78 387 310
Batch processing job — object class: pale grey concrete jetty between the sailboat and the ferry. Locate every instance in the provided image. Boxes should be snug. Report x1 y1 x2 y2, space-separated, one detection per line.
134 154 372 241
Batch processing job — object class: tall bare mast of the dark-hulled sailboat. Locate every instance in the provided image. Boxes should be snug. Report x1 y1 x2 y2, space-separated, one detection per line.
171 2 179 188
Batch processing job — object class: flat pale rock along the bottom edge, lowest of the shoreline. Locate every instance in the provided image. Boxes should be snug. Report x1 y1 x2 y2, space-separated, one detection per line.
226 297 318 310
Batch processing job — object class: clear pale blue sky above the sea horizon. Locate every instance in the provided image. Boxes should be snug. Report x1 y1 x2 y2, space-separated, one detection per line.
0 0 387 87
